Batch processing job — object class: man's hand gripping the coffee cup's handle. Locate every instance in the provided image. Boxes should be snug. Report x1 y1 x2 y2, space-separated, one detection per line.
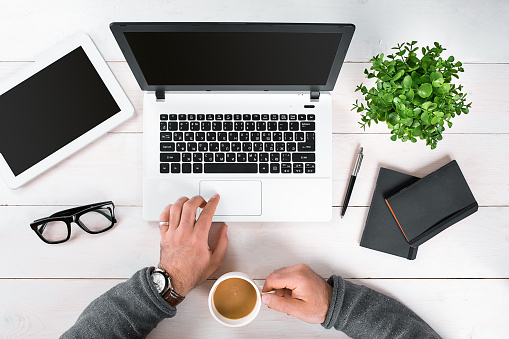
262 264 332 324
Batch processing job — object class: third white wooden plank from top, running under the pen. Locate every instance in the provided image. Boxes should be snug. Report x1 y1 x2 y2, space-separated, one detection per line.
0 133 509 206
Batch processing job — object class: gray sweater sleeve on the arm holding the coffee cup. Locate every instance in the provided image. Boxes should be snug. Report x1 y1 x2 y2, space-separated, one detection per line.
322 275 440 339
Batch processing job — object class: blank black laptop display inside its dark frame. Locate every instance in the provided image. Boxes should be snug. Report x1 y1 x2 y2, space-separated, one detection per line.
124 32 342 86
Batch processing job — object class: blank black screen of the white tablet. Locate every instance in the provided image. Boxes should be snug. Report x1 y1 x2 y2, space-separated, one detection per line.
0 47 120 176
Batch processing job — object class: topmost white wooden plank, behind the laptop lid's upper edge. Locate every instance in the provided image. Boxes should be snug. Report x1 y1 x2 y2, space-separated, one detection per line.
0 0 509 63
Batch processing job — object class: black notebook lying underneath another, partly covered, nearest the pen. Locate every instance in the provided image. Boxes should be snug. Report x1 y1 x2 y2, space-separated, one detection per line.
360 167 419 260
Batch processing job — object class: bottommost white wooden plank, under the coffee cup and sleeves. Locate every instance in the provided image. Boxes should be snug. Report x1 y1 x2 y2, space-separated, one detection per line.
0 279 509 339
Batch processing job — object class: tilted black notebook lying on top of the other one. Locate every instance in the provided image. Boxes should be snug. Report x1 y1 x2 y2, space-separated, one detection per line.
386 160 478 246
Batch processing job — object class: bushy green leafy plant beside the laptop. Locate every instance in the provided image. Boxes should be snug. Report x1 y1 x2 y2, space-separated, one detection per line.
352 41 472 149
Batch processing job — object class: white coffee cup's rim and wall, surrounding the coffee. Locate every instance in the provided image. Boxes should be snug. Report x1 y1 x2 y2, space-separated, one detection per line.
209 272 262 327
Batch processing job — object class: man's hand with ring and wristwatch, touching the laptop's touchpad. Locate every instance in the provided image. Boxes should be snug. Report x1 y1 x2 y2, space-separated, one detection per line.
159 194 228 296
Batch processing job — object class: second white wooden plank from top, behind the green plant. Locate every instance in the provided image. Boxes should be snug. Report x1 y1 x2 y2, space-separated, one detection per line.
0 62 509 134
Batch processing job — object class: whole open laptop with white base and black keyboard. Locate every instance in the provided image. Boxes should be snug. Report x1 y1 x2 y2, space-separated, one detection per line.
110 22 355 222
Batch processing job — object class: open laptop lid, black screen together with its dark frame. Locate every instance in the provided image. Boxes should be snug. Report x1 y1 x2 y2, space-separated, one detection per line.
110 22 355 92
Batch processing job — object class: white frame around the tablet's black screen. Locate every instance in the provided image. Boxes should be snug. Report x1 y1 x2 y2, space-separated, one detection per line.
0 34 134 189
